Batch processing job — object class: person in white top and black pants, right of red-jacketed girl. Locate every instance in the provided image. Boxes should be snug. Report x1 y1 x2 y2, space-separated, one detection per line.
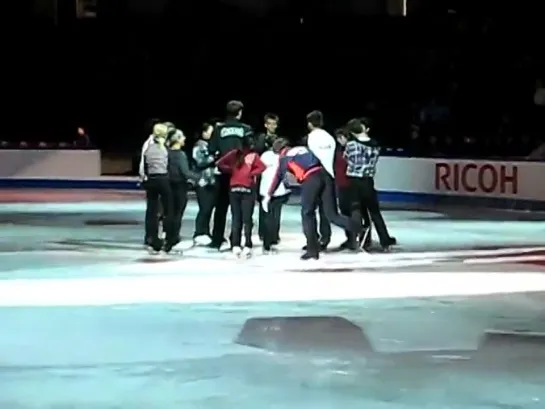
259 138 291 254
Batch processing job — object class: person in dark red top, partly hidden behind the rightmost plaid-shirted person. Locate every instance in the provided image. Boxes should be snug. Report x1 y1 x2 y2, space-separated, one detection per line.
335 128 371 251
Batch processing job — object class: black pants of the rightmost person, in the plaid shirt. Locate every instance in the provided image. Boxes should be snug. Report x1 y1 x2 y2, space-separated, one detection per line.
348 178 390 246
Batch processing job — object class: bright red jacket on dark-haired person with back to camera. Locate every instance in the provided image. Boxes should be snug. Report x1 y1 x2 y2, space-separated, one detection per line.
216 149 267 189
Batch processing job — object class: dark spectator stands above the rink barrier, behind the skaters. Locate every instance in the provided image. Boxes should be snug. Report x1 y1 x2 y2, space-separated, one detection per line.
4 2 545 160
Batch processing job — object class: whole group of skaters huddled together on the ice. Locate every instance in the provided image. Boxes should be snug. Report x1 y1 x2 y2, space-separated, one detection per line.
140 101 396 260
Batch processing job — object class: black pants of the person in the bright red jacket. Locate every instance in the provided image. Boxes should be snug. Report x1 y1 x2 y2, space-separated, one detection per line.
229 192 255 248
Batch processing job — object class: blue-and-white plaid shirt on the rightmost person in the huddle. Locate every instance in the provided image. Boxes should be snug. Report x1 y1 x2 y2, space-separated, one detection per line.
343 139 380 178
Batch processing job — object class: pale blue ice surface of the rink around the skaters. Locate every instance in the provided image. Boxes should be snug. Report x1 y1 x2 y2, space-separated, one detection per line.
0 191 545 409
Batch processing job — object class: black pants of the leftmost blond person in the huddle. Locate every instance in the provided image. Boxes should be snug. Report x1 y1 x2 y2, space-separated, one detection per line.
144 175 172 250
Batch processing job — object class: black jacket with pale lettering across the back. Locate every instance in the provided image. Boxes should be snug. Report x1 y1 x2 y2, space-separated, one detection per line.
208 119 253 157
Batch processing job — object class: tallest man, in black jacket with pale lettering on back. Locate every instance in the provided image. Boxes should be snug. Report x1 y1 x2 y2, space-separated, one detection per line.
209 101 253 250
